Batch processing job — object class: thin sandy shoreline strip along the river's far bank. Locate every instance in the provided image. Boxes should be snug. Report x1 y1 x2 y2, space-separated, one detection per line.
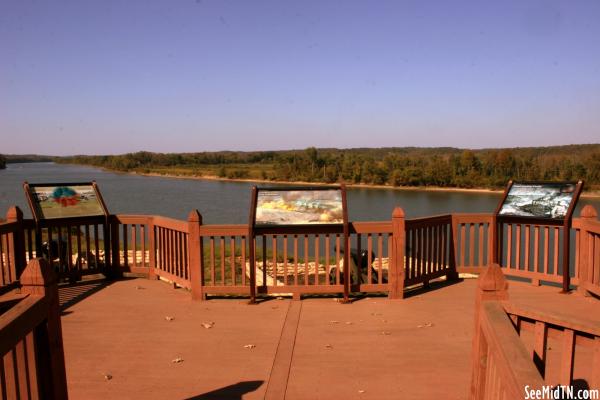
120 168 600 198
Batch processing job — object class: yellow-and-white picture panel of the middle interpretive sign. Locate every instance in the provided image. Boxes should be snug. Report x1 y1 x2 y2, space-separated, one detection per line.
255 189 344 227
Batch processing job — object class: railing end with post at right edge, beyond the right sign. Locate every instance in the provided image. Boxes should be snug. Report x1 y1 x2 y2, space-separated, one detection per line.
573 205 600 296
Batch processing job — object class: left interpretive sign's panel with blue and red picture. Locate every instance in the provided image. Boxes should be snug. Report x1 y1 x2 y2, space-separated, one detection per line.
24 182 106 220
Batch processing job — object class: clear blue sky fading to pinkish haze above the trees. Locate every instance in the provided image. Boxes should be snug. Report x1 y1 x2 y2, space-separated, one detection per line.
0 0 600 155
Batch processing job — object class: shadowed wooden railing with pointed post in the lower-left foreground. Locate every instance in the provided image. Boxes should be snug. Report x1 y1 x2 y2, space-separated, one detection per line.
0 259 67 399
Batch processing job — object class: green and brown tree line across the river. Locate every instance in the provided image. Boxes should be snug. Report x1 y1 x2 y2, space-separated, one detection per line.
55 144 600 189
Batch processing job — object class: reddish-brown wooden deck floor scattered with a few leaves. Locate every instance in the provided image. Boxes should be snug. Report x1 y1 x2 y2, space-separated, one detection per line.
61 279 600 400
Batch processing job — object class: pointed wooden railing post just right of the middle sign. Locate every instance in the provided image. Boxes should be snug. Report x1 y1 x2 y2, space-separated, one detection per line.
388 207 406 299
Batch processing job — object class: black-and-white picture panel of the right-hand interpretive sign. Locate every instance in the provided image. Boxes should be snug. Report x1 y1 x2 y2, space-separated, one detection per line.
498 182 577 220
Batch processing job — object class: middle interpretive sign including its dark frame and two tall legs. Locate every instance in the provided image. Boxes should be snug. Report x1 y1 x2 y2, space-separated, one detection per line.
248 185 350 303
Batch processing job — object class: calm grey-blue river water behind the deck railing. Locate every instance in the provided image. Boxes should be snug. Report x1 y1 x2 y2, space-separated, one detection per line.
0 163 600 224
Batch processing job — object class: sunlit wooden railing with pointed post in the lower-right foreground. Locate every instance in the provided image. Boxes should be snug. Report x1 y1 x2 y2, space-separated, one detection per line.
471 264 600 399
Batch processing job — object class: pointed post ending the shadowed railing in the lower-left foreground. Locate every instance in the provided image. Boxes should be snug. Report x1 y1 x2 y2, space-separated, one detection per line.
21 258 67 399
